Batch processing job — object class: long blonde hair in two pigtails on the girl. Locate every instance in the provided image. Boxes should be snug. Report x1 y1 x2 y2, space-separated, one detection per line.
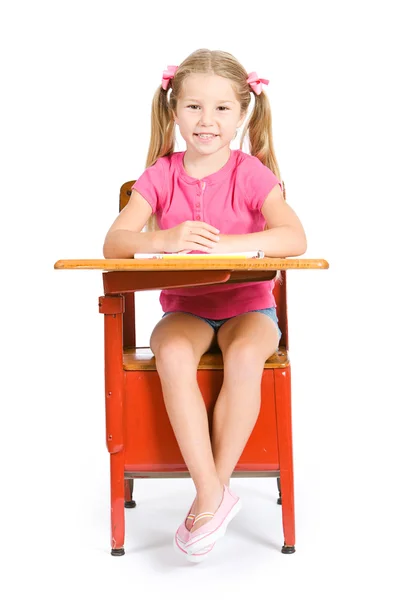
146 49 285 282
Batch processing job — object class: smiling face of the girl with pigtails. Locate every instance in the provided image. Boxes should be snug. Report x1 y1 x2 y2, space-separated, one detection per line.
174 74 246 157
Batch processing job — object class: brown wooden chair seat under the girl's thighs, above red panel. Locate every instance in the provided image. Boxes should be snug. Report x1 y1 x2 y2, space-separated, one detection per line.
123 346 289 371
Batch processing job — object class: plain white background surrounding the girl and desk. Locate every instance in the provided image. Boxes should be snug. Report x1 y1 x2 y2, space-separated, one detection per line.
0 0 410 598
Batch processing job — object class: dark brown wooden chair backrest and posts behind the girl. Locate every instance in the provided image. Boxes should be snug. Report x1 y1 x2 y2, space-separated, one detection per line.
120 179 289 350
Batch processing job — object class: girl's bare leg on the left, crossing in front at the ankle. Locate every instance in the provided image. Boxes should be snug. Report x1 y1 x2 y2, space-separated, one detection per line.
150 313 223 528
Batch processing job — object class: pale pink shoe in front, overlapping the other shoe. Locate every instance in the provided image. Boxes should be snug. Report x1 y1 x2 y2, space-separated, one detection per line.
185 485 242 554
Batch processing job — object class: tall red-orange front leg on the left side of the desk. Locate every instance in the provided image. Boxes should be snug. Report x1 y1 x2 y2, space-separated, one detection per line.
99 294 125 556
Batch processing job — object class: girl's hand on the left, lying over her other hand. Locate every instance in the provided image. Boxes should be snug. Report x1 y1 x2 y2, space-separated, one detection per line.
161 221 219 253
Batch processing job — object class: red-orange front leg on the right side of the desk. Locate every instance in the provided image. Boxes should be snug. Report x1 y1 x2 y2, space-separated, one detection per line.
274 366 295 554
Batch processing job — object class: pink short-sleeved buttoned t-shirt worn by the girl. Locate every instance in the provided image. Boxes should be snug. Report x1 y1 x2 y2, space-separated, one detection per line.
132 150 282 319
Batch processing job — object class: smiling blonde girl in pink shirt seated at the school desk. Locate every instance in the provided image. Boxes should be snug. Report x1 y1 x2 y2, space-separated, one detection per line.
103 50 306 562
